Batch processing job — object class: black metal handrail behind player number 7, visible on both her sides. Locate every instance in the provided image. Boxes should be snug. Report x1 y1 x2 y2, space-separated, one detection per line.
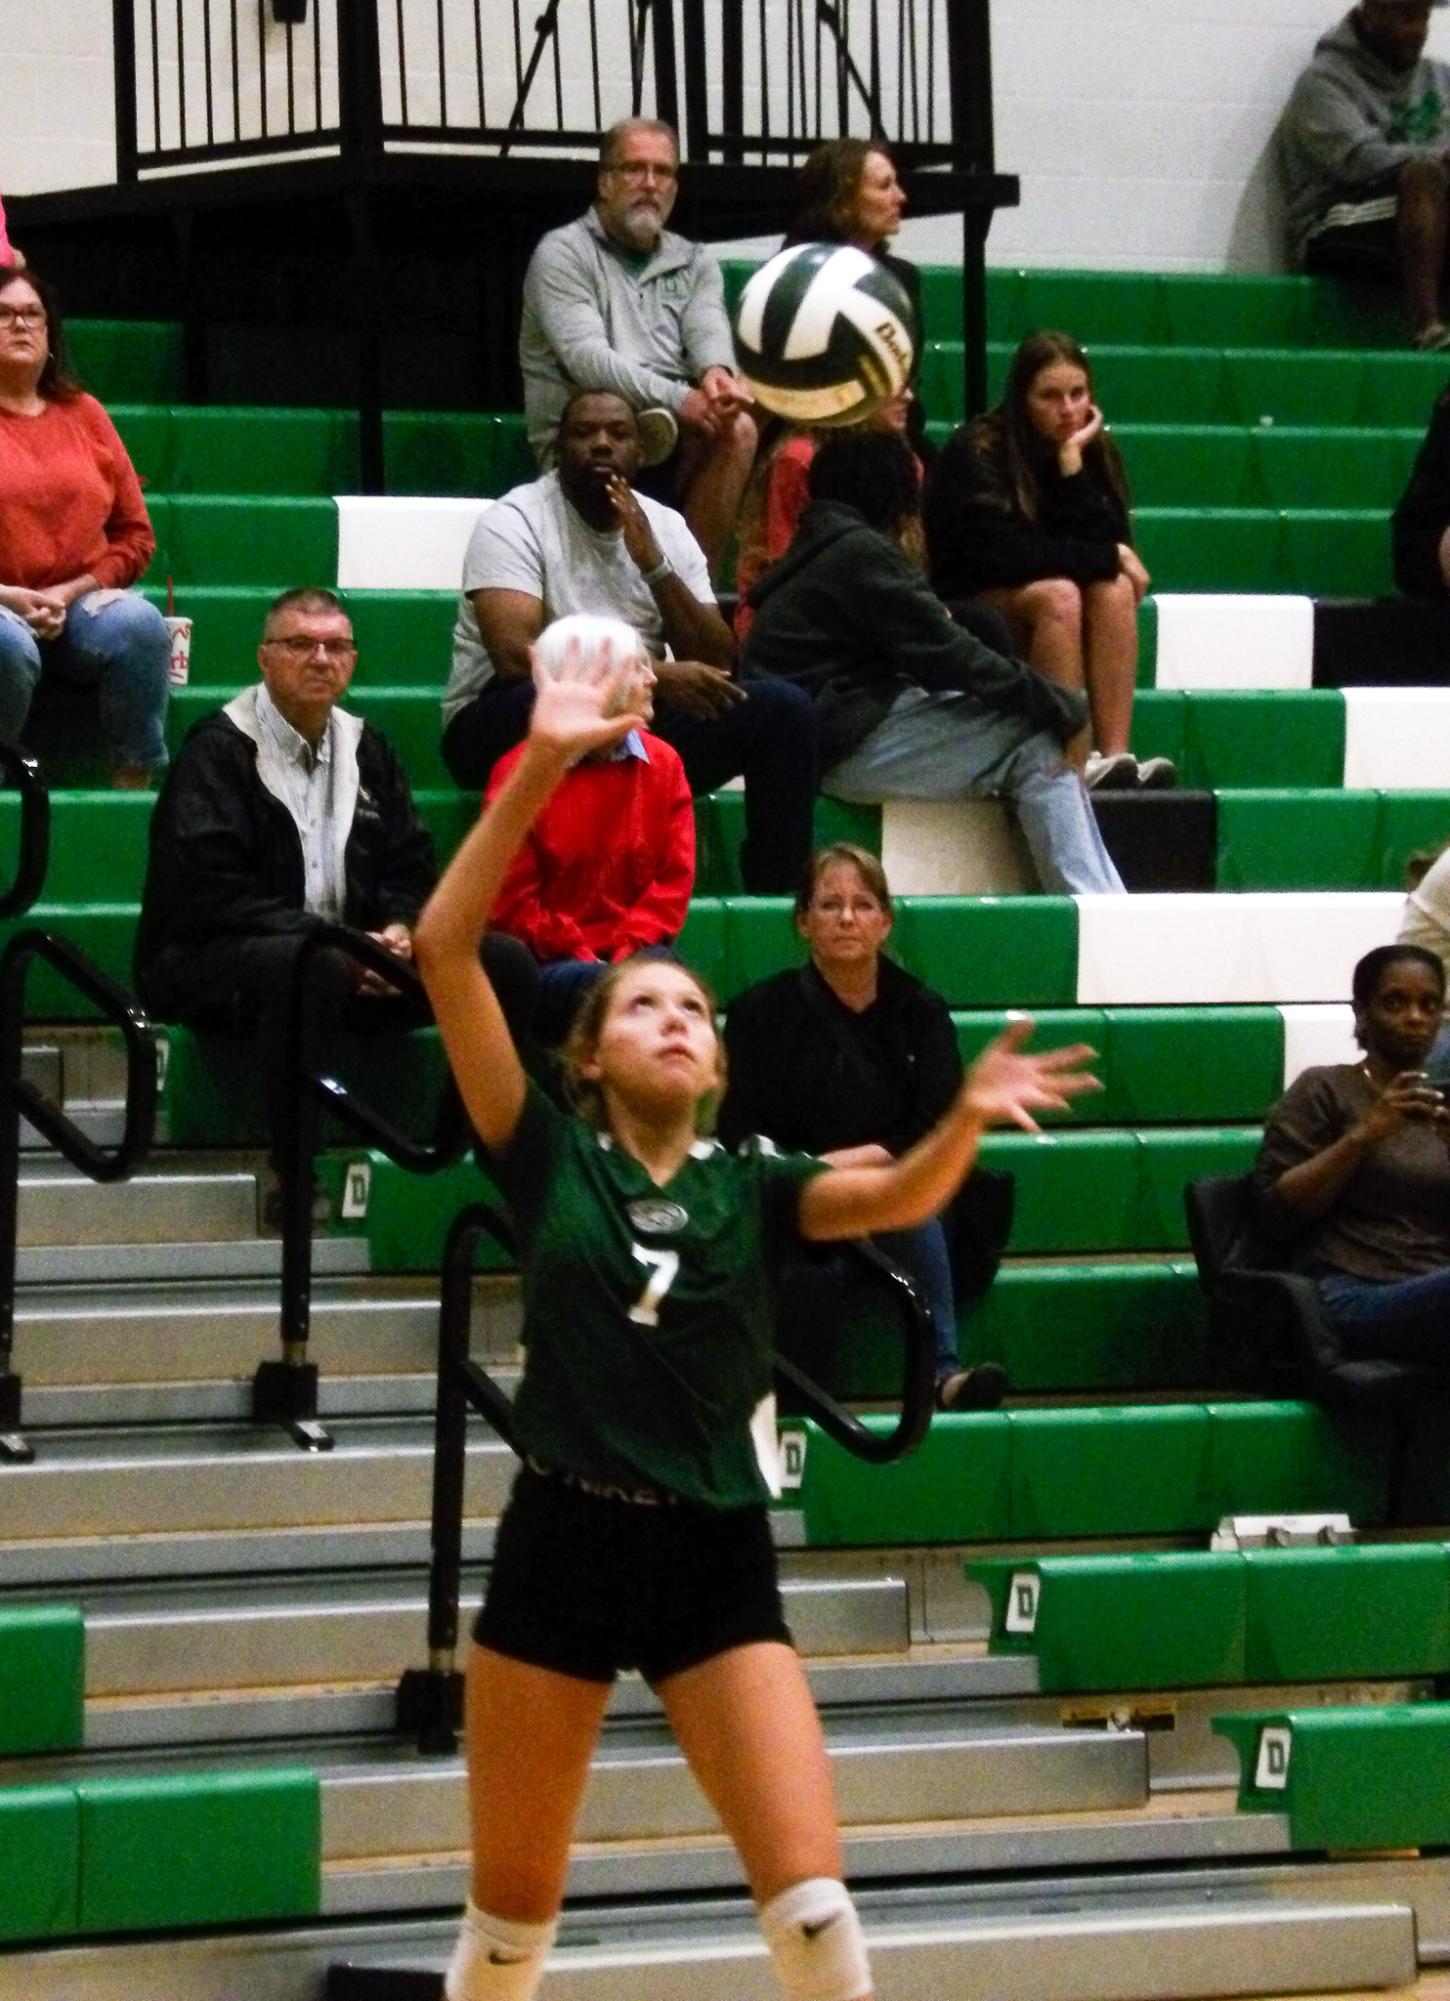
396 1203 936 1753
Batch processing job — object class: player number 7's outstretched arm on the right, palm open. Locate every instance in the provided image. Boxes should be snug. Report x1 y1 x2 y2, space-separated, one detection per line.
800 1019 1100 1243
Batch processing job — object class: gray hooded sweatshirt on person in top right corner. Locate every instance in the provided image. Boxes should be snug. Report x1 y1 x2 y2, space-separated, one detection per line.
1278 12 1450 258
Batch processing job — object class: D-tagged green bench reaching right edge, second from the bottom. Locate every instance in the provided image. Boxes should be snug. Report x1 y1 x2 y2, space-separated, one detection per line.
966 1543 1450 1695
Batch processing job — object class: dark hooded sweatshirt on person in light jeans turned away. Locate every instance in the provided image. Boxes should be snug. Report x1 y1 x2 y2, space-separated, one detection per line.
744 500 1088 770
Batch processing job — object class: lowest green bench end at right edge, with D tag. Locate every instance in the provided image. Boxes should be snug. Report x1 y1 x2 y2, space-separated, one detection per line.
1214 1703 1450 1851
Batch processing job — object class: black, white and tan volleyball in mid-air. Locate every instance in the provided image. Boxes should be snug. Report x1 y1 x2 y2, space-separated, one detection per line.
736 244 916 426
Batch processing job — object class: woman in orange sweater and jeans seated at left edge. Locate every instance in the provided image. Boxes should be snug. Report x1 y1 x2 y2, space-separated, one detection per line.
0 268 170 788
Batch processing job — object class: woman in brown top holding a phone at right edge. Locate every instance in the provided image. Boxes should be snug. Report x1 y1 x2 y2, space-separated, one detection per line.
1256 944 1450 1361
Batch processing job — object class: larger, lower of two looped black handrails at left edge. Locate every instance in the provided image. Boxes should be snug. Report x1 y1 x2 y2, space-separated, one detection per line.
0 928 156 1461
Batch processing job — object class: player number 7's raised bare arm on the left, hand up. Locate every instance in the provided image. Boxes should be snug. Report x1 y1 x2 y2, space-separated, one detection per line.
412 646 642 1153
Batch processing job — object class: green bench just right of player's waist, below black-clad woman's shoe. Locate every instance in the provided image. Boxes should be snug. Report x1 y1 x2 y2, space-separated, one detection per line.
802 1403 1386 1547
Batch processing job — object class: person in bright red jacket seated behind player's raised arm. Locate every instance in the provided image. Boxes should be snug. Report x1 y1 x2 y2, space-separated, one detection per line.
488 614 694 1043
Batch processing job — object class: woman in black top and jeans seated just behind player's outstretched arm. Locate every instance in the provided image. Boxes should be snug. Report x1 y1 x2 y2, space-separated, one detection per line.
720 840 1006 1411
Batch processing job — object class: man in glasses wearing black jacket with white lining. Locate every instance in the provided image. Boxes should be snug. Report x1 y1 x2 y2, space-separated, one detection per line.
136 586 538 1221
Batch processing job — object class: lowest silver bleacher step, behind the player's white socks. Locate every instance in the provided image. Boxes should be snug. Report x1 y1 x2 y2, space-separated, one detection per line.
0 1871 1416 2001
